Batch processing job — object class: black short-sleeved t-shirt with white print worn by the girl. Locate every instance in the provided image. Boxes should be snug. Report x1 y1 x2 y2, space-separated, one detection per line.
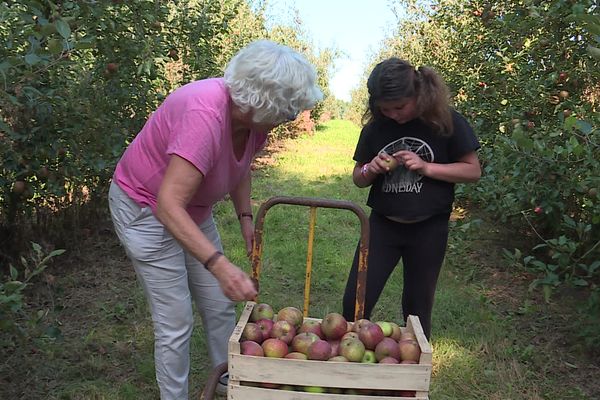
354 110 480 221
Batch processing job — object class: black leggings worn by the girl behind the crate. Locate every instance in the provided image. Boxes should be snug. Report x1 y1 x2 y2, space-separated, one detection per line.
343 212 449 338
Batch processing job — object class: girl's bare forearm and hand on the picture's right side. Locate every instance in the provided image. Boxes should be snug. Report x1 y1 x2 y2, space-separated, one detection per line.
394 150 481 183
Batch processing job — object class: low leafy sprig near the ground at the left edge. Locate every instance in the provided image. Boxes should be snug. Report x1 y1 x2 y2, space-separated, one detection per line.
0 242 65 344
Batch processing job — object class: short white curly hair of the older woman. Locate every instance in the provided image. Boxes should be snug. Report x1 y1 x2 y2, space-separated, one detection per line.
224 40 323 124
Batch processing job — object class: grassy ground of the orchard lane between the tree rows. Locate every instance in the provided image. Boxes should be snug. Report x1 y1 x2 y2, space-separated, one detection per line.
0 121 600 400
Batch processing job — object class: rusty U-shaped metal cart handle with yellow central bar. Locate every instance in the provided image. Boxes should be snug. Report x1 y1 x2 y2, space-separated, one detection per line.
252 196 369 320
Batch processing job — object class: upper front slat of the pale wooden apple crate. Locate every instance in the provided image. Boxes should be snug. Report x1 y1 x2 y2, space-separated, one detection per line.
229 354 431 391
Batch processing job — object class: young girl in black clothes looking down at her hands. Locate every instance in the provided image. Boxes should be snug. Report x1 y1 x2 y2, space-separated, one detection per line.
343 58 481 338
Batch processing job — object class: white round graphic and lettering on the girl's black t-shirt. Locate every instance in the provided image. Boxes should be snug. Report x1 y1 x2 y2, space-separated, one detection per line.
381 136 434 193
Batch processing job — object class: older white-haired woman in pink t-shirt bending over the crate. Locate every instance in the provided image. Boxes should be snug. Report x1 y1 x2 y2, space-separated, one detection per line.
109 40 322 399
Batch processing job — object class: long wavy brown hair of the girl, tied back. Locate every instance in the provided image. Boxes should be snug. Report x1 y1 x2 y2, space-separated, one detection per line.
362 57 453 136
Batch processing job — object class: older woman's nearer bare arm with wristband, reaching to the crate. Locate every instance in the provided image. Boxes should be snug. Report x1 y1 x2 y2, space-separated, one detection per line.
156 155 256 301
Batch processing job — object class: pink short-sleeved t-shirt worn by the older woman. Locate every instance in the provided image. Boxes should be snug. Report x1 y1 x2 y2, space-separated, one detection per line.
113 78 267 222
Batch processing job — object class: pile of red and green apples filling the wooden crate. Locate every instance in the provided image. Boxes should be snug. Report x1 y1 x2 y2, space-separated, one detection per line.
240 303 421 364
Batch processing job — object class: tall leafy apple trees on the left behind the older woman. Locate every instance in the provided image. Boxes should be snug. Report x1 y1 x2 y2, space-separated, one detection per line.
0 0 331 256
